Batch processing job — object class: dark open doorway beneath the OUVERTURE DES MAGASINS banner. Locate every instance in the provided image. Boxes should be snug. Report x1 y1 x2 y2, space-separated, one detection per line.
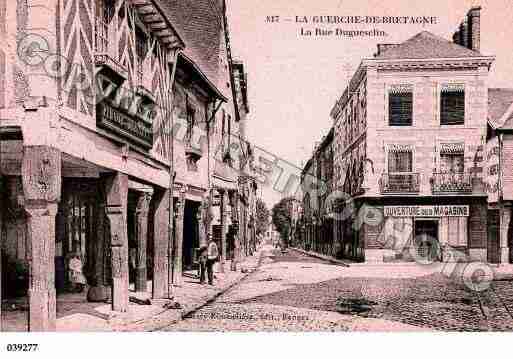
414 220 441 262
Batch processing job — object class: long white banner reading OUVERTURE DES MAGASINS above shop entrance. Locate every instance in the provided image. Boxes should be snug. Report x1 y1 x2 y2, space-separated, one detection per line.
385 206 469 217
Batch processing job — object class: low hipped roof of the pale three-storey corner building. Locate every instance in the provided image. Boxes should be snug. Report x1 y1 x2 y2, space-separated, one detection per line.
375 31 482 60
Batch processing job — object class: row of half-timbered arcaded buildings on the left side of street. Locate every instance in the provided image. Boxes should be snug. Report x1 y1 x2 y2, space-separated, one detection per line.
0 0 254 331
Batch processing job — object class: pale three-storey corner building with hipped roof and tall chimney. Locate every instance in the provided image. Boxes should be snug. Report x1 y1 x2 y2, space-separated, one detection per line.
302 7 494 262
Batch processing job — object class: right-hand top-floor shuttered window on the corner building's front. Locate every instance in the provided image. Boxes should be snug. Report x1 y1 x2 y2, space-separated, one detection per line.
440 84 465 125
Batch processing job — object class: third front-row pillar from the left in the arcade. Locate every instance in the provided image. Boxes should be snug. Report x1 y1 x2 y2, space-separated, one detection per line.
151 190 173 299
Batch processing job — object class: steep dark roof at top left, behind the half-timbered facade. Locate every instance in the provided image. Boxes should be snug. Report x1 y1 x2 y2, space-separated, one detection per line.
160 0 225 93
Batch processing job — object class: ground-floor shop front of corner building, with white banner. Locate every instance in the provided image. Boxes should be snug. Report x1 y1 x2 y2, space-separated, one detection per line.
359 198 487 262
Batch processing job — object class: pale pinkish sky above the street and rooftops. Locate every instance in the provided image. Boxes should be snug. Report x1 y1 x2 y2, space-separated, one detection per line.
227 0 513 207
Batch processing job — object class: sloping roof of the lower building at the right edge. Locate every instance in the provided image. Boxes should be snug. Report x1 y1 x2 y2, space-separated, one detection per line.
488 88 513 129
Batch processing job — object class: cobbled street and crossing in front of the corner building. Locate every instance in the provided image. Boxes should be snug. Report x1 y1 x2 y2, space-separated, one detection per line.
166 248 513 331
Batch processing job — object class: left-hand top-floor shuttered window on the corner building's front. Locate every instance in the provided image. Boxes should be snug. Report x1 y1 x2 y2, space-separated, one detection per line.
388 85 413 126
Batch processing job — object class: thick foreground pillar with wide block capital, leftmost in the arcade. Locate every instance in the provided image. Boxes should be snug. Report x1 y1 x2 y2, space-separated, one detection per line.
21 146 62 332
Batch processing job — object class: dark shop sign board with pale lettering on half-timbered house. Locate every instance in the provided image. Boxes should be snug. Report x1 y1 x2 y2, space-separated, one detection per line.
96 102 153 148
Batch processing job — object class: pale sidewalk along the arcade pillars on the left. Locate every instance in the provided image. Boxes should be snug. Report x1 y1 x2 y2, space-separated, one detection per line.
2 252 261 332
